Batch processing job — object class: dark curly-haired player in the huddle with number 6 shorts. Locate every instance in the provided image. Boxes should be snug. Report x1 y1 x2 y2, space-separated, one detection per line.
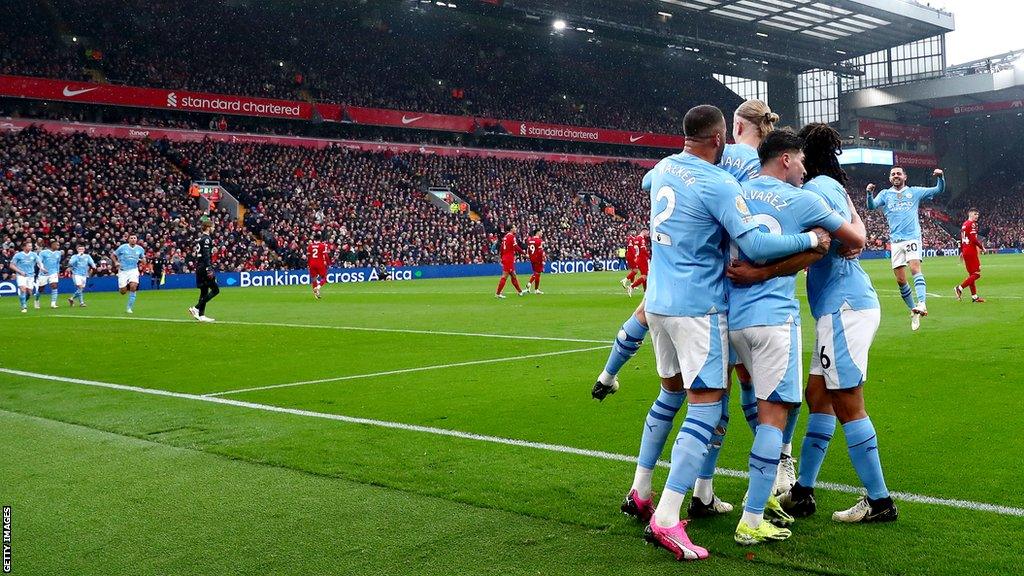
779 124 898 523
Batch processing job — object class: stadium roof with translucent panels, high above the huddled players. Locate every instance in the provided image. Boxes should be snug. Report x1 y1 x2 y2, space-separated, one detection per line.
468 0 953 75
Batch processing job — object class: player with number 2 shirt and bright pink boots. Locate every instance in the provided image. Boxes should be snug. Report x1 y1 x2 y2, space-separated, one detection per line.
623 106 829 560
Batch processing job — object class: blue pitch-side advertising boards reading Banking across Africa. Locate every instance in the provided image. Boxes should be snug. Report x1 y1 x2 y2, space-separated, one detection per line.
0 248 1007 296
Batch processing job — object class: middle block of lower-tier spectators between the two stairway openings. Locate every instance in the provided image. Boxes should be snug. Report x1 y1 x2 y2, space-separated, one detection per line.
170 140 488 268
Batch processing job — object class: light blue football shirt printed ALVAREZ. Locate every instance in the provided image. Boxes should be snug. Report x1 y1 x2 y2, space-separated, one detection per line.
729 175 844 330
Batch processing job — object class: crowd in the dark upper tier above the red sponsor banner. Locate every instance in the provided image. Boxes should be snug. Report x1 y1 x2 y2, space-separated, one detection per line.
3 0 739 133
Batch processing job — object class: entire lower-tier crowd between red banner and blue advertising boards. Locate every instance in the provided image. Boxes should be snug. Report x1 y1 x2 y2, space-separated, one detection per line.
8 128 1024 284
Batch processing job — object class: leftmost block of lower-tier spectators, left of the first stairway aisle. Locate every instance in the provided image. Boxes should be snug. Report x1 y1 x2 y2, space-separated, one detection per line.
0 128 278 277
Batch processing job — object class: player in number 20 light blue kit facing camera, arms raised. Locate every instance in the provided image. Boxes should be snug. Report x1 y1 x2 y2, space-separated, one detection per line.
867 166 946 330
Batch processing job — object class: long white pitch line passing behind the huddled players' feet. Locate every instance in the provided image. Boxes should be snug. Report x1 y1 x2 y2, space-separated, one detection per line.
6 368 1024 518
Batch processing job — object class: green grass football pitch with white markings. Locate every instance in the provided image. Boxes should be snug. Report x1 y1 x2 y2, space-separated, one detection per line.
0 255 1024 576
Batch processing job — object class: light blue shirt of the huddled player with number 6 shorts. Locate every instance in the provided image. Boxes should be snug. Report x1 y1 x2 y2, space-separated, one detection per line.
804 176 879 319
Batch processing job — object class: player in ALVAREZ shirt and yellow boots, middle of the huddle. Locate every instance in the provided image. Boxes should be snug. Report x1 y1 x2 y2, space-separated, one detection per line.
729 129 864 545
